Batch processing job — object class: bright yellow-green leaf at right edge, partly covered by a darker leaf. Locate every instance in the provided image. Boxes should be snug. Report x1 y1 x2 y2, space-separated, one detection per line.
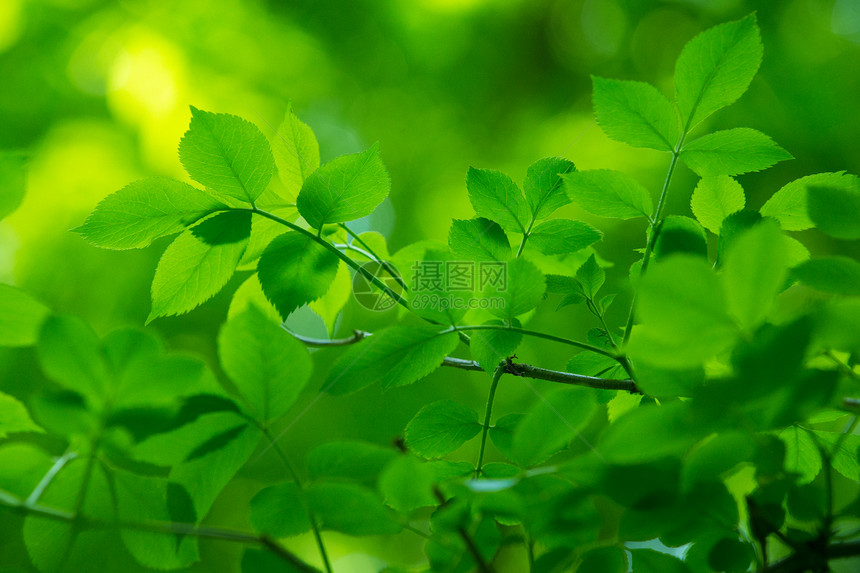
761 171 860 231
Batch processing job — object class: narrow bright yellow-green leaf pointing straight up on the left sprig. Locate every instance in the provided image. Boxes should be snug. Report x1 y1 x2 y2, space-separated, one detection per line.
272 108 320 196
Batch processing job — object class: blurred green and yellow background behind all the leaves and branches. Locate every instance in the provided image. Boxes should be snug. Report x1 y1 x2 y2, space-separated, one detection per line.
0 0 860 571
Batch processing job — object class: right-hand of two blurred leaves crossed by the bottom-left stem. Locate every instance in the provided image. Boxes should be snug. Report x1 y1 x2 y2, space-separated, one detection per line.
112 470 200 569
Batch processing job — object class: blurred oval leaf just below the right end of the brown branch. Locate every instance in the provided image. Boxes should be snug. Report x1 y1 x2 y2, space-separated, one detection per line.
597 402 704 465
